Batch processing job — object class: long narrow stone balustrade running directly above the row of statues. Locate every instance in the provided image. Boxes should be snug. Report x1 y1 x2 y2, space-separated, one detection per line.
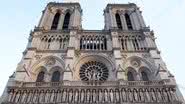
8 79 173 87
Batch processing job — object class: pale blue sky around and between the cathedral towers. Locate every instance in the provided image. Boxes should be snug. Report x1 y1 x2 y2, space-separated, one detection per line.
0 0 185 96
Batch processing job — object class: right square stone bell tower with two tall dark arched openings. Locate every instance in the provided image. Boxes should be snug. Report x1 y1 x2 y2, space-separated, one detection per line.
104 3 146 30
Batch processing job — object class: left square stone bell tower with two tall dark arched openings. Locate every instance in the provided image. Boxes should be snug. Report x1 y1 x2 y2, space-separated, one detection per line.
38 2 82 30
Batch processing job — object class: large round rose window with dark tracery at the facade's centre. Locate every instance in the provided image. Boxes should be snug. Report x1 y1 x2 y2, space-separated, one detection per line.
80 61 109 81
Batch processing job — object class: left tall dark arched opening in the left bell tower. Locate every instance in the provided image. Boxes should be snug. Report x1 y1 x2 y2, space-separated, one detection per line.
51 12 60 30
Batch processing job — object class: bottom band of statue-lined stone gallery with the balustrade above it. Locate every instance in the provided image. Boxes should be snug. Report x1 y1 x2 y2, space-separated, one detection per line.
4 80 182 104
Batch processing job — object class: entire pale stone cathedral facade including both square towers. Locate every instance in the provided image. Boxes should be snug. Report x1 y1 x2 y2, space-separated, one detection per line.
1 2 184 104
